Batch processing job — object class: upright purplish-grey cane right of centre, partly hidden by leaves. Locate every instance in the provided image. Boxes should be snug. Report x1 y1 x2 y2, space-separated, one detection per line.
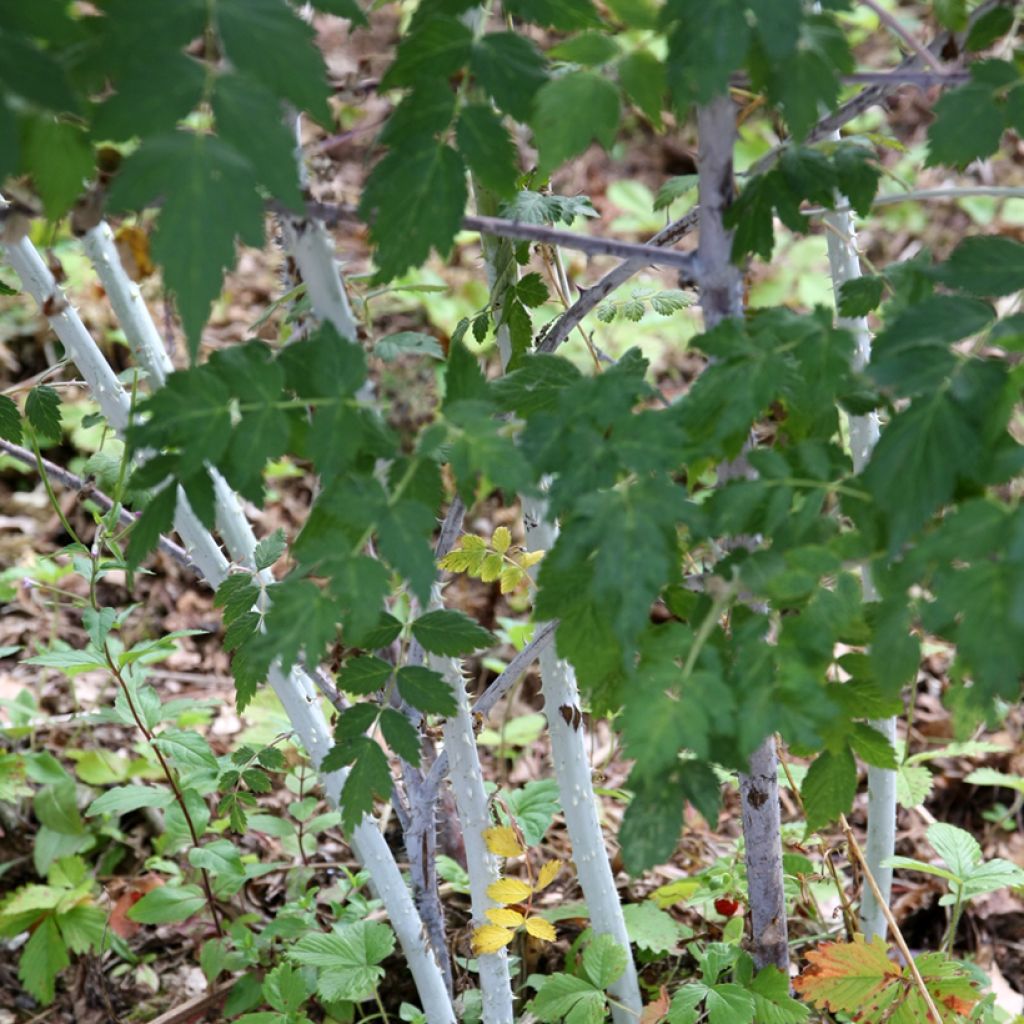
697 95 790 973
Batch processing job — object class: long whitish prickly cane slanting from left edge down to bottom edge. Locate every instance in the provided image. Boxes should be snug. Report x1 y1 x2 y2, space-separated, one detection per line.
5 203 455 1024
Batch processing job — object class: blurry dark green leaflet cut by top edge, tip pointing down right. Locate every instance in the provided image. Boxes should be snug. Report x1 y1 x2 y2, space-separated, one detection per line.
215 0 331 125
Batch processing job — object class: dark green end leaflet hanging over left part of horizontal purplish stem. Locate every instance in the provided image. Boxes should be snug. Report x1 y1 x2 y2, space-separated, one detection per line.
359 139 467 281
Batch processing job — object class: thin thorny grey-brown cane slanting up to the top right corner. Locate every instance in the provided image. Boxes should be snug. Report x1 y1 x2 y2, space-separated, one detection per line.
538 0 1012 360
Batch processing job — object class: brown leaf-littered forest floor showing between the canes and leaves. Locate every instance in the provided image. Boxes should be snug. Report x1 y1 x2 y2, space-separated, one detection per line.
0 6 1024 1024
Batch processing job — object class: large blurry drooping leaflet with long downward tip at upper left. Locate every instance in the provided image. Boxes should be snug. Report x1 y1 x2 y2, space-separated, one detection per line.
111 133 266 358
